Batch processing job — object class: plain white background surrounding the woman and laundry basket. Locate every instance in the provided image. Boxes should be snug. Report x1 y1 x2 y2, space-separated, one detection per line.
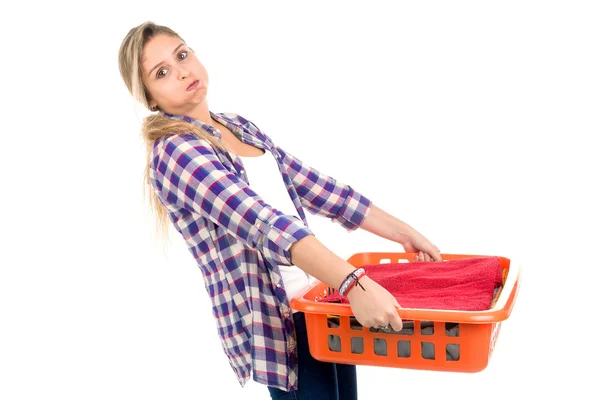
0 1 600 400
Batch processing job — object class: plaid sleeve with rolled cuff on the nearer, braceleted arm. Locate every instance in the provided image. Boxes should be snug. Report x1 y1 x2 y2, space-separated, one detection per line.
153 134 313 265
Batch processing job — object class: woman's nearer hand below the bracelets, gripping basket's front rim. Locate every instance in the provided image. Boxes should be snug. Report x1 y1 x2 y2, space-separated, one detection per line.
346 276 402 331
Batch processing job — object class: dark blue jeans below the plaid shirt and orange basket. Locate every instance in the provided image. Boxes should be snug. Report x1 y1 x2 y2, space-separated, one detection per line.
268 312 358 400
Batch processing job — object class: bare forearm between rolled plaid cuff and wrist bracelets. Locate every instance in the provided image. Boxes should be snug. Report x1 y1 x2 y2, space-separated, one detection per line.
290 235 356 289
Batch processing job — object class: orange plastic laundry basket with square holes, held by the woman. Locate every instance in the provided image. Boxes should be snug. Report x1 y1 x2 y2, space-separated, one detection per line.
290 252 520 372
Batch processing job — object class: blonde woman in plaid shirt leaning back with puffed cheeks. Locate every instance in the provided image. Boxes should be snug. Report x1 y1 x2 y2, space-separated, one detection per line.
119 22 441 400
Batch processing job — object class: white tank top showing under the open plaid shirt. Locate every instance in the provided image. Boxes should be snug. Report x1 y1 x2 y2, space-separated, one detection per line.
241 150 315 312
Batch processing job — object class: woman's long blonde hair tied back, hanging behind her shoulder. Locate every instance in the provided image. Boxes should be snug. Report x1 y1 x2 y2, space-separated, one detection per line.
119 21 225 250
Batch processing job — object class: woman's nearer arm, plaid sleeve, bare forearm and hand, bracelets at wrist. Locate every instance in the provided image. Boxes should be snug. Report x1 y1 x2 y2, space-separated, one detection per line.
153 135 402 330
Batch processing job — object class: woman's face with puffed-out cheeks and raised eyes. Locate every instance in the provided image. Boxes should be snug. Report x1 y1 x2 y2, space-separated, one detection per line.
142 34 208 115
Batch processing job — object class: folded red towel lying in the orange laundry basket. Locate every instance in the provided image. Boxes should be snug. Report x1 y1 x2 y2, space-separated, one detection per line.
320 257 502 311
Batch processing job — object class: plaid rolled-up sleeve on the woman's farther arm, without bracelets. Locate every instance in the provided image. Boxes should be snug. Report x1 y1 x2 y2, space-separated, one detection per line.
275 146 372 232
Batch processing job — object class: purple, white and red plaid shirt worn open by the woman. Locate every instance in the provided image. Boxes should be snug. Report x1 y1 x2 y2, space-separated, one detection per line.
150 112 371 391
